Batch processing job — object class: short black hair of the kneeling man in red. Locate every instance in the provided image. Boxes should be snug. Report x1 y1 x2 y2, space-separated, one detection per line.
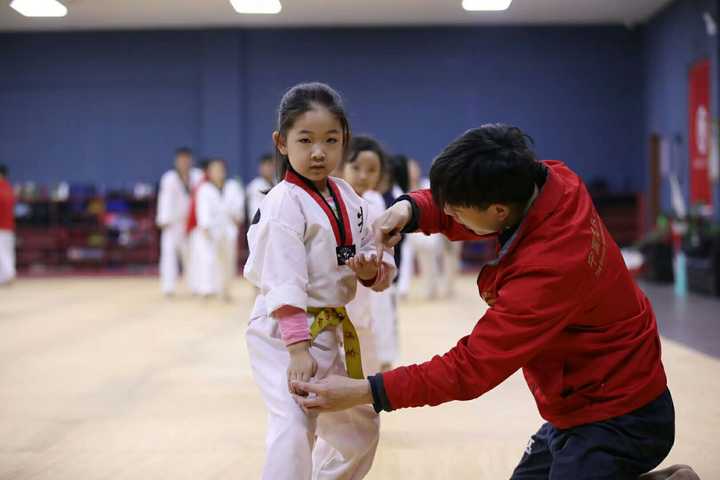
430 123 543 210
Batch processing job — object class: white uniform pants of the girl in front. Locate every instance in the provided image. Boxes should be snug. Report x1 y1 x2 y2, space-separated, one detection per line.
247 316 380 480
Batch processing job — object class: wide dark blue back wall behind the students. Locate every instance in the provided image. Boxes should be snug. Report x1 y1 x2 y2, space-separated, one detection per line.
0 27 645 189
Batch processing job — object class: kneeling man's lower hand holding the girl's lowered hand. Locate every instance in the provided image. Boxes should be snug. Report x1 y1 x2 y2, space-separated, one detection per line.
291 375 373 413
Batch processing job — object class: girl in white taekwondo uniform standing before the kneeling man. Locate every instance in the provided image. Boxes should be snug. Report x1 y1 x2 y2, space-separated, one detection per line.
245 83 395 480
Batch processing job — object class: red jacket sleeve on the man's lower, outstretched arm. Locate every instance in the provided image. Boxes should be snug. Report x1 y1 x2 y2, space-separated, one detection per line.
382 266 581 410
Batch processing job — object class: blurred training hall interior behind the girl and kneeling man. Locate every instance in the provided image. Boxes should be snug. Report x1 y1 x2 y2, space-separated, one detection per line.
0 0 720 480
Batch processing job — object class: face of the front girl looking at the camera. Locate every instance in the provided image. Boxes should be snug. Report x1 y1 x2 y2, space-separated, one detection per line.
273 106 344 190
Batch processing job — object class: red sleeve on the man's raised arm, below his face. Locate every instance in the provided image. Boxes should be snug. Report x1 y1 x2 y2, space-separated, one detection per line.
408 189 494 241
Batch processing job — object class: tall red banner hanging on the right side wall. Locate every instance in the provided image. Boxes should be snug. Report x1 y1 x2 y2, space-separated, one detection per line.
688 60 712 205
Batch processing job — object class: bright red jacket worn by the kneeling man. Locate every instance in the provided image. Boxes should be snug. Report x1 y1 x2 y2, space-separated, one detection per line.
382 161 666 428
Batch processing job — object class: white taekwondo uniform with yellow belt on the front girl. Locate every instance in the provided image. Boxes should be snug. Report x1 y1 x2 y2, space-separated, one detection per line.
245 171 395 480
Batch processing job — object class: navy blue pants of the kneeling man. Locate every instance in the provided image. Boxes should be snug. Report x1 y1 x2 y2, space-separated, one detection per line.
512 390 675 480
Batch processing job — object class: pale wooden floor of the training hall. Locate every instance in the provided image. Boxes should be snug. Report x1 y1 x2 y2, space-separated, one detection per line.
0 277 720 480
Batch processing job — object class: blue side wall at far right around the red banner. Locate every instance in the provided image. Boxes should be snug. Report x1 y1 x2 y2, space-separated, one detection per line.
643 0 720 212
